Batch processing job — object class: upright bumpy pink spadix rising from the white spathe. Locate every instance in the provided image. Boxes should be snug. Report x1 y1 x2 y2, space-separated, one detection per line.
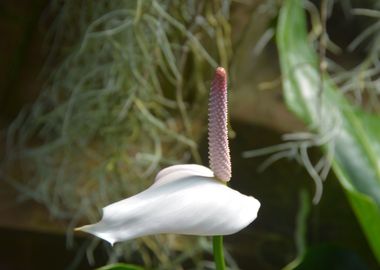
208 67 231 182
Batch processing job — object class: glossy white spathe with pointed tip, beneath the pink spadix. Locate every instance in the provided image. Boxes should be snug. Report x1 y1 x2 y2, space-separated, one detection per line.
78 164 260 245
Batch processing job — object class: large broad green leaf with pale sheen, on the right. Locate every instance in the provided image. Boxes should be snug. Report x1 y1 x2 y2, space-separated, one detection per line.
277 0 380 262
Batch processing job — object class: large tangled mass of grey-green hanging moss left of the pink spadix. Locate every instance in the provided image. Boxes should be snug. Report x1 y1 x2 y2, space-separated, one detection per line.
3 0 230 269
